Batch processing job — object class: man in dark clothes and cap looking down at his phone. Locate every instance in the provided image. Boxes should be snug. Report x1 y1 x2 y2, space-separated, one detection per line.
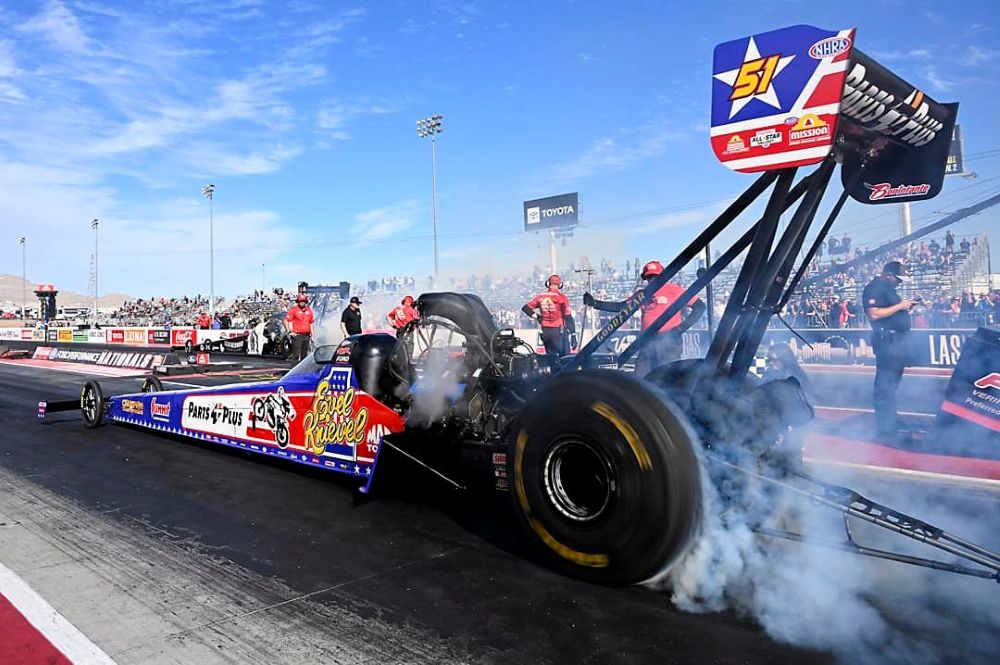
861 261 916 442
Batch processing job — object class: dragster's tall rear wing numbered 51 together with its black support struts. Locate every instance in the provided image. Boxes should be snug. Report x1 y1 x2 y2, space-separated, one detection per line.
561 25 958 374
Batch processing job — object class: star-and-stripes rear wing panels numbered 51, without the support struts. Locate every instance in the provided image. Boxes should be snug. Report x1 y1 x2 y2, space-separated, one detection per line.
711 25 958 204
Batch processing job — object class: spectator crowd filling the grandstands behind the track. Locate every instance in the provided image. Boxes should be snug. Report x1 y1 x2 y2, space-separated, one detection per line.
25 231 1000 329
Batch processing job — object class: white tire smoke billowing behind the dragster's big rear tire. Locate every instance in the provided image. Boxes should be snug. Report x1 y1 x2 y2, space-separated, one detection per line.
659 434 1000 665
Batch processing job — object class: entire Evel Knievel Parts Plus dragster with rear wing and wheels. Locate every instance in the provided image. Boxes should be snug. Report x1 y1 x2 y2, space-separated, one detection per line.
39 25 1000 584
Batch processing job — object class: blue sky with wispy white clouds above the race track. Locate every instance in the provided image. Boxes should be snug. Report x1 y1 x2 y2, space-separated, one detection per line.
0 0 1000 296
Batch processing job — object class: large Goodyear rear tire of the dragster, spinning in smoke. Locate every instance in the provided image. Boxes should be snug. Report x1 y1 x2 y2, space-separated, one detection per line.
507 370 701 585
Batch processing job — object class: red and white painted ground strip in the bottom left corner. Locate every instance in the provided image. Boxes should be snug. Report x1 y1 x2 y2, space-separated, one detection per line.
0 563 115 665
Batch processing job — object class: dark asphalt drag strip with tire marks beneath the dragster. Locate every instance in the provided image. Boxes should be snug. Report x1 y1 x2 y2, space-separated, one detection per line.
0 364 832 663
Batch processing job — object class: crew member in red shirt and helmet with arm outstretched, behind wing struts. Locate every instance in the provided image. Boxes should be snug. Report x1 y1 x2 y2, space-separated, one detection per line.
583 261 706 376
